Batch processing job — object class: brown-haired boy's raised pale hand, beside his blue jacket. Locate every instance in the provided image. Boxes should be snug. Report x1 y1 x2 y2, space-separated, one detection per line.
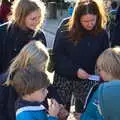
48 99 60 117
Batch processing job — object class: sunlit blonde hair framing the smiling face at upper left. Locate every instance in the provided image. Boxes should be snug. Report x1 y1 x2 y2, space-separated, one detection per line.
10 0 45 27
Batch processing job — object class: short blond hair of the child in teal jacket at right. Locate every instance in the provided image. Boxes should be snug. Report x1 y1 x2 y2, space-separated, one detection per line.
96 47 120 79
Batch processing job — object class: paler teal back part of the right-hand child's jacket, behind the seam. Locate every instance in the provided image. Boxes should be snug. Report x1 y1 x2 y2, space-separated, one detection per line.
98 80 120 120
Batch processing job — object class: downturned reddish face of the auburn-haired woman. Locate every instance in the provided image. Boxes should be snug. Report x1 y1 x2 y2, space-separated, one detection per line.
80 14 97 31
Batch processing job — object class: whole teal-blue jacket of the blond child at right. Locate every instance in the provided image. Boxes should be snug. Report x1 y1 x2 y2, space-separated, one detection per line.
80 80 120 120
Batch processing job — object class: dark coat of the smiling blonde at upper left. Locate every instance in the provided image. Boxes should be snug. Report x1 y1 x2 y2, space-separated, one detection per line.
0 23 46 73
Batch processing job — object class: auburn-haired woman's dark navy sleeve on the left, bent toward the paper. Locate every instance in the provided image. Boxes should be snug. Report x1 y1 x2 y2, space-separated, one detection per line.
53 21 78 77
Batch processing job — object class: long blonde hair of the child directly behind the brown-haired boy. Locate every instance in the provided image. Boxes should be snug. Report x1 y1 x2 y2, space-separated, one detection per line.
7 41 49 84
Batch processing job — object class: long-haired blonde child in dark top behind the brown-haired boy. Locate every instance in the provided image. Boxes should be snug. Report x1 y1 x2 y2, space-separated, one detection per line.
0 41 49 120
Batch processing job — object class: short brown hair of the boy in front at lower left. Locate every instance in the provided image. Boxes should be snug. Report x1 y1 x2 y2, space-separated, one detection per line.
11 67 50 96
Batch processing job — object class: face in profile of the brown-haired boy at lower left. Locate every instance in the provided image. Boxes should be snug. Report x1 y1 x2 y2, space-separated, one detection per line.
31 88 48 102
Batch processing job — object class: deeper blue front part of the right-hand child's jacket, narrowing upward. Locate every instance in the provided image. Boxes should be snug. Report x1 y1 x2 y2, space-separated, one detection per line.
80 89 104 120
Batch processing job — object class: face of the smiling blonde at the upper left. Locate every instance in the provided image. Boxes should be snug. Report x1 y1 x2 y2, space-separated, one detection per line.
25 10 41 30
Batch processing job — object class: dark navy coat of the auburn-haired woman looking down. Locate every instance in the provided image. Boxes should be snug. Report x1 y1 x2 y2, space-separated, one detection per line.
53 19 108 78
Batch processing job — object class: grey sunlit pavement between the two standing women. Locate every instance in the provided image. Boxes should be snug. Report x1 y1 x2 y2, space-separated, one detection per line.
42 10 68 48
